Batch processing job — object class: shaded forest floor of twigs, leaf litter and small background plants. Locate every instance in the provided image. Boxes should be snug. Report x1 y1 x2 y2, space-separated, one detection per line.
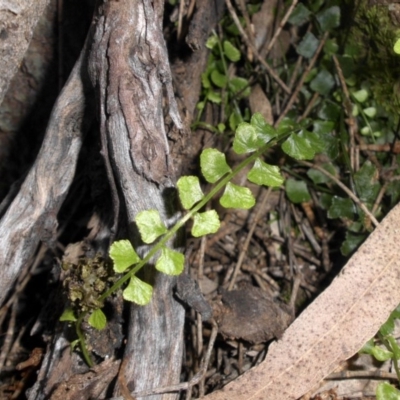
0 1 400 399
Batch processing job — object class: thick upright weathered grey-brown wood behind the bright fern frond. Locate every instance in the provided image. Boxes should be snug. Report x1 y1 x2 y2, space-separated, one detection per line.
89 0 184 400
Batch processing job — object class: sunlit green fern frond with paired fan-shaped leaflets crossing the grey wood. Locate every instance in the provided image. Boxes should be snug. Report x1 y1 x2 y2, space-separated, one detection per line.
62 114 332 365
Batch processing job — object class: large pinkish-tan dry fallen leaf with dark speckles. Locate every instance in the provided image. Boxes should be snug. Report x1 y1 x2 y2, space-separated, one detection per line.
204 205 400 400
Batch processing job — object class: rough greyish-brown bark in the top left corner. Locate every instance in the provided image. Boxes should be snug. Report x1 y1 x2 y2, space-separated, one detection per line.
0 0 49 103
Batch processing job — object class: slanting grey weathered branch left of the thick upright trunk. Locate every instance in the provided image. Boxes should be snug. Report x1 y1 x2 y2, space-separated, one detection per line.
0 50 91 304
